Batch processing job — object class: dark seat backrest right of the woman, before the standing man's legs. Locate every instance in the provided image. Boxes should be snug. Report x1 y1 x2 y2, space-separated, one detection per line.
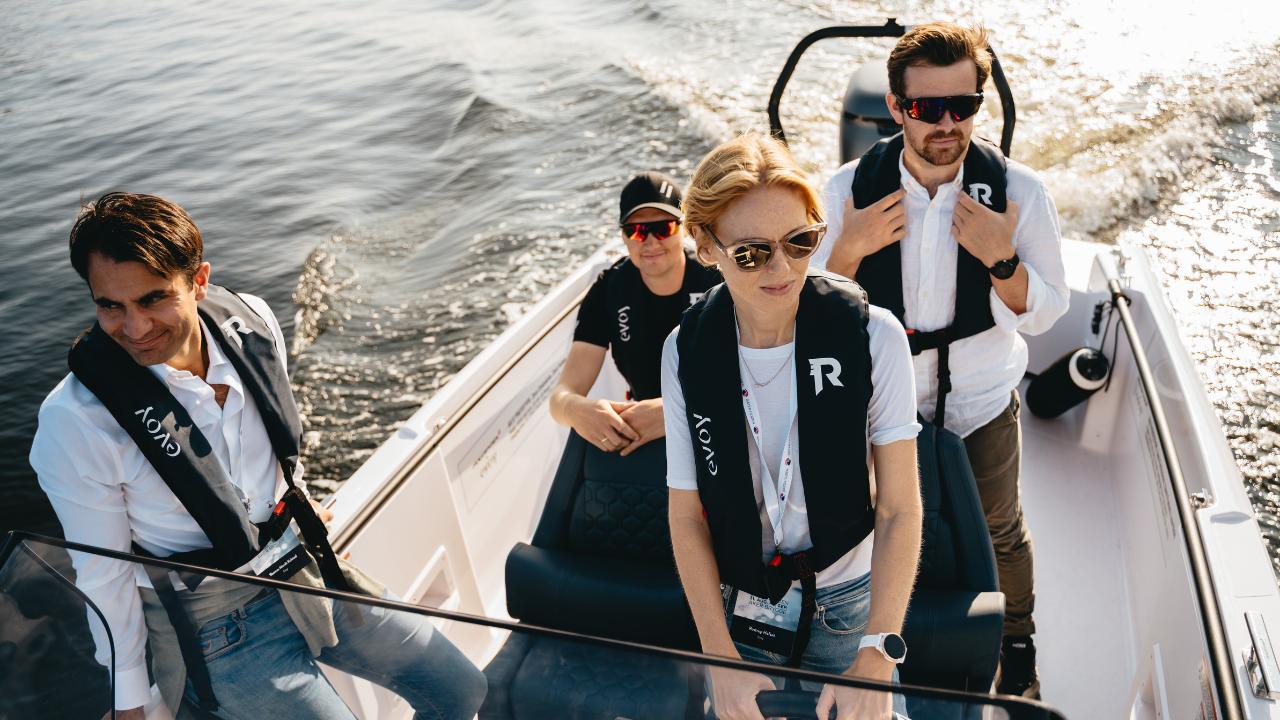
915 423 998 592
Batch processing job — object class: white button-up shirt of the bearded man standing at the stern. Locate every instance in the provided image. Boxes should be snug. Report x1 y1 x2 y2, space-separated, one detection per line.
813 149 1070 437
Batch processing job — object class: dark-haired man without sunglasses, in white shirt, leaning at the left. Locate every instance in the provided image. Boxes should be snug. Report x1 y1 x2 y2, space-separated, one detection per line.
31 192 485 720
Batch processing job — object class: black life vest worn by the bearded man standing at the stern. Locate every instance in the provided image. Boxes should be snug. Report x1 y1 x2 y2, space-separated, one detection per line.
852 133 1007 428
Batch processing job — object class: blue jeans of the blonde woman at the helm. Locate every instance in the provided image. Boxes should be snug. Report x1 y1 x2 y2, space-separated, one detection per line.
724 573 906 716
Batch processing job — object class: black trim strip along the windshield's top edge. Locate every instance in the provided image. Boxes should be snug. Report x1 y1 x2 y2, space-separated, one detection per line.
2 530 1065 720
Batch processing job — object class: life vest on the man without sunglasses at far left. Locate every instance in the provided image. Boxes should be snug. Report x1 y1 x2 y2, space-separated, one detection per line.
68 284 348 589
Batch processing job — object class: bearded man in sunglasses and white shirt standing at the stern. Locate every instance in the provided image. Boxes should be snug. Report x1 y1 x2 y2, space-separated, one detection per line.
815 23 1069 697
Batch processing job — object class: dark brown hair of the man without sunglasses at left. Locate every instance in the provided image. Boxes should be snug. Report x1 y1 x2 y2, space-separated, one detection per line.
70 192 205 282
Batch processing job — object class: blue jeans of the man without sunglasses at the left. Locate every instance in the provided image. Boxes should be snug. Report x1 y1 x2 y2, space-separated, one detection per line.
187 591 486 720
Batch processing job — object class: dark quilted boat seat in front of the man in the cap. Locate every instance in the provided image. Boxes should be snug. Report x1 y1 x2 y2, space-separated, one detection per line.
480 432 703 720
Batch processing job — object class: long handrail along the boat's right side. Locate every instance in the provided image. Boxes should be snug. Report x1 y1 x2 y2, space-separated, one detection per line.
1107 278 1244 720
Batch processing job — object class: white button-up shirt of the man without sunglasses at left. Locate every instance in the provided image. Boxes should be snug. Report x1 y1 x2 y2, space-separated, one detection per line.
31 295 302 710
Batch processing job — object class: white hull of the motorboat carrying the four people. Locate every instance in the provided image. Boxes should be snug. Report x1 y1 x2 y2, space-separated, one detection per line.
322 242 1280 720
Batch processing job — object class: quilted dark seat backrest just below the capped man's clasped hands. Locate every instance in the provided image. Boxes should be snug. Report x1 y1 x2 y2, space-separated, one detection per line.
532 432 673 564
